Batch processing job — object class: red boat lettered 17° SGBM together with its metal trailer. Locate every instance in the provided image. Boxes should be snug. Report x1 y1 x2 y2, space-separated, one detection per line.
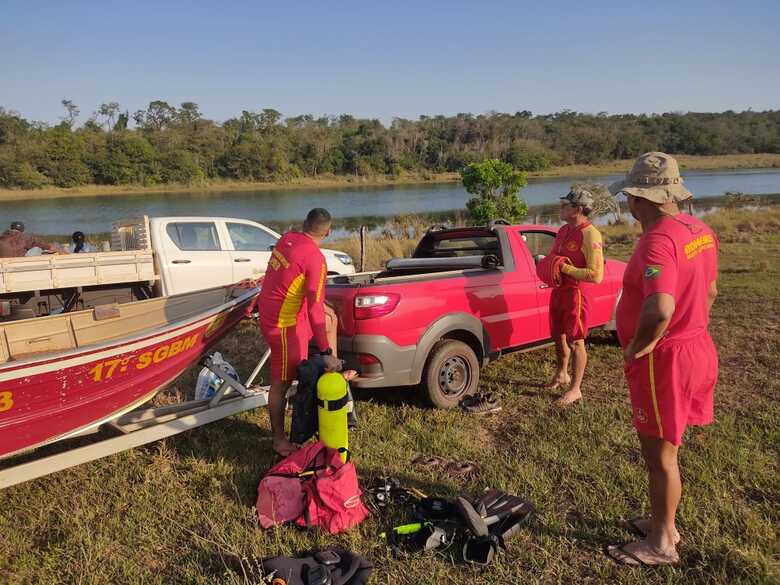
0 285 267 488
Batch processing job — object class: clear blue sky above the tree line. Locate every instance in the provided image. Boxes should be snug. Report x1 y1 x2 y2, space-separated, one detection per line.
0 0 780 122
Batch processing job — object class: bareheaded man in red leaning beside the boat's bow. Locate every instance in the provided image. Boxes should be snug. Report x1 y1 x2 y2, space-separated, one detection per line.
259 208 339 456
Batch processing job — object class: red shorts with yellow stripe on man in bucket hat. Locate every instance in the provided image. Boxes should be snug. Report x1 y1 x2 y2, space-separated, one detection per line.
624 333 718 445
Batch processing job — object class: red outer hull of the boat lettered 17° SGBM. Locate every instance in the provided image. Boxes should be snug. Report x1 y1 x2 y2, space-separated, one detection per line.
0 289 257 458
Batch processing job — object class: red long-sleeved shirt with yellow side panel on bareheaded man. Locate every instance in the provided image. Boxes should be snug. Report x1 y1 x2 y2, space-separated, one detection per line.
259 232 328 350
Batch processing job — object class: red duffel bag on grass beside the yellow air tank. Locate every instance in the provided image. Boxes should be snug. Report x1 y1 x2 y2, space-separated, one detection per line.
256 441 368 534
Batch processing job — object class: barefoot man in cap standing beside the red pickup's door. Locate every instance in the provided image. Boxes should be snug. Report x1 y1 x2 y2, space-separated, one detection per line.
547 187 604 406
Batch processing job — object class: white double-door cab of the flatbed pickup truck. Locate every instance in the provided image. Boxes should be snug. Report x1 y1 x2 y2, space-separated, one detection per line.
150 217 355 295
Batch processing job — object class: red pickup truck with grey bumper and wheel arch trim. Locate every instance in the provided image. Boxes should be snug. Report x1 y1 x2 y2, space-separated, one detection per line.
326 223 625 408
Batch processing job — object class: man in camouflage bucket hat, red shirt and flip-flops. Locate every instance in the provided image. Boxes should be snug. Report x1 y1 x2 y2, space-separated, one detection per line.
607 152 718 565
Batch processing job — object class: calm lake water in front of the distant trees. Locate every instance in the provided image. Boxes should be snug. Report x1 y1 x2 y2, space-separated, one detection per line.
6 169 780 234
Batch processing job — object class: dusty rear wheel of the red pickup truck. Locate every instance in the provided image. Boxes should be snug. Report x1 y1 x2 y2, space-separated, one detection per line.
423 339 479 408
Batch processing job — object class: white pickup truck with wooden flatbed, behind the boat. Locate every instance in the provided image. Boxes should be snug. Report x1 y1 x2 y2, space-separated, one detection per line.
0 216 355 319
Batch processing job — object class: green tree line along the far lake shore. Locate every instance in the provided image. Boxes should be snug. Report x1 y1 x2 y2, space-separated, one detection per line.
0 100 780 188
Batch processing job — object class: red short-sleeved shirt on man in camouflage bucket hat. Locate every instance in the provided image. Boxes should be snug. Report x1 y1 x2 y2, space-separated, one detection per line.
617 213 719 347
